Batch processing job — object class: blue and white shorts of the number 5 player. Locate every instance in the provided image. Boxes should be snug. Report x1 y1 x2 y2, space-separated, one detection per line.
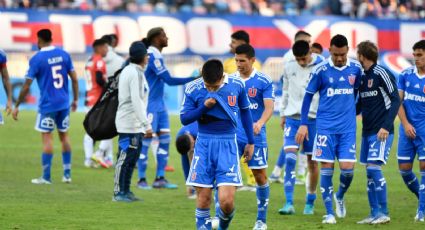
34 109 69 133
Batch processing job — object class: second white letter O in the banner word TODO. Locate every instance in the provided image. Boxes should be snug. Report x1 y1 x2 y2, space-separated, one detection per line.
187 18 233 55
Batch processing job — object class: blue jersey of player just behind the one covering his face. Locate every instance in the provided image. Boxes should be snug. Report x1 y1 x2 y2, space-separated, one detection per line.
233 69 274 146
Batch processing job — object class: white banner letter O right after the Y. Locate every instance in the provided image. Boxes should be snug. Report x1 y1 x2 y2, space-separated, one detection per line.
330 21 378 49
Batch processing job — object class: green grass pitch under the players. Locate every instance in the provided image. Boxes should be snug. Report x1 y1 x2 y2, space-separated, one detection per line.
0 111 425 229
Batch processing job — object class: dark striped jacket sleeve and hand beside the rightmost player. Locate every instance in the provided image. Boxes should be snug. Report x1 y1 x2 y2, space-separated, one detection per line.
377 71 400 140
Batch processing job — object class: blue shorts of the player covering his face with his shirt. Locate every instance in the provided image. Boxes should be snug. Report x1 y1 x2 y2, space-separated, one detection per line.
186 133 242 188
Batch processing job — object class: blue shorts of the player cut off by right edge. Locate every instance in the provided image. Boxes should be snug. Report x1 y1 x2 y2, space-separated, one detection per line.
397 130 425 164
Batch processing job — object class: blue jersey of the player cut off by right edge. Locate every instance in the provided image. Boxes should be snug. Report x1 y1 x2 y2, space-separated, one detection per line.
398 67 425 136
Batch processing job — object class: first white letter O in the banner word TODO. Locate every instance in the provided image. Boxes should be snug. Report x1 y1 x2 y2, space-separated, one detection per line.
93 16 141 53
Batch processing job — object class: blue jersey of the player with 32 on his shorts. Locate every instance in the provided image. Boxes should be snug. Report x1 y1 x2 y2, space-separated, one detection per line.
306 58 362 134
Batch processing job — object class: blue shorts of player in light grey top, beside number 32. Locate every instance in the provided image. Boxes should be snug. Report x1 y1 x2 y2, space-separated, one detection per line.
283 118 316 155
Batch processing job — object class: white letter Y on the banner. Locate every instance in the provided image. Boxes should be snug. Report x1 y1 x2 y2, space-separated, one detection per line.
273 19 329 42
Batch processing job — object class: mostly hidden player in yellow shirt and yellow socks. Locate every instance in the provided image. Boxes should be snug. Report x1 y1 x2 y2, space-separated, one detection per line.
223 30 261 192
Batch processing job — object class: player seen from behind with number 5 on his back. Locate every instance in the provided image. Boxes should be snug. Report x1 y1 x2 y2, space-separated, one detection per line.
12 29 78 184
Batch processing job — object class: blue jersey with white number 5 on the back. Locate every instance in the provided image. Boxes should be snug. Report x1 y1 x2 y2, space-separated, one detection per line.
26 46 74 114
